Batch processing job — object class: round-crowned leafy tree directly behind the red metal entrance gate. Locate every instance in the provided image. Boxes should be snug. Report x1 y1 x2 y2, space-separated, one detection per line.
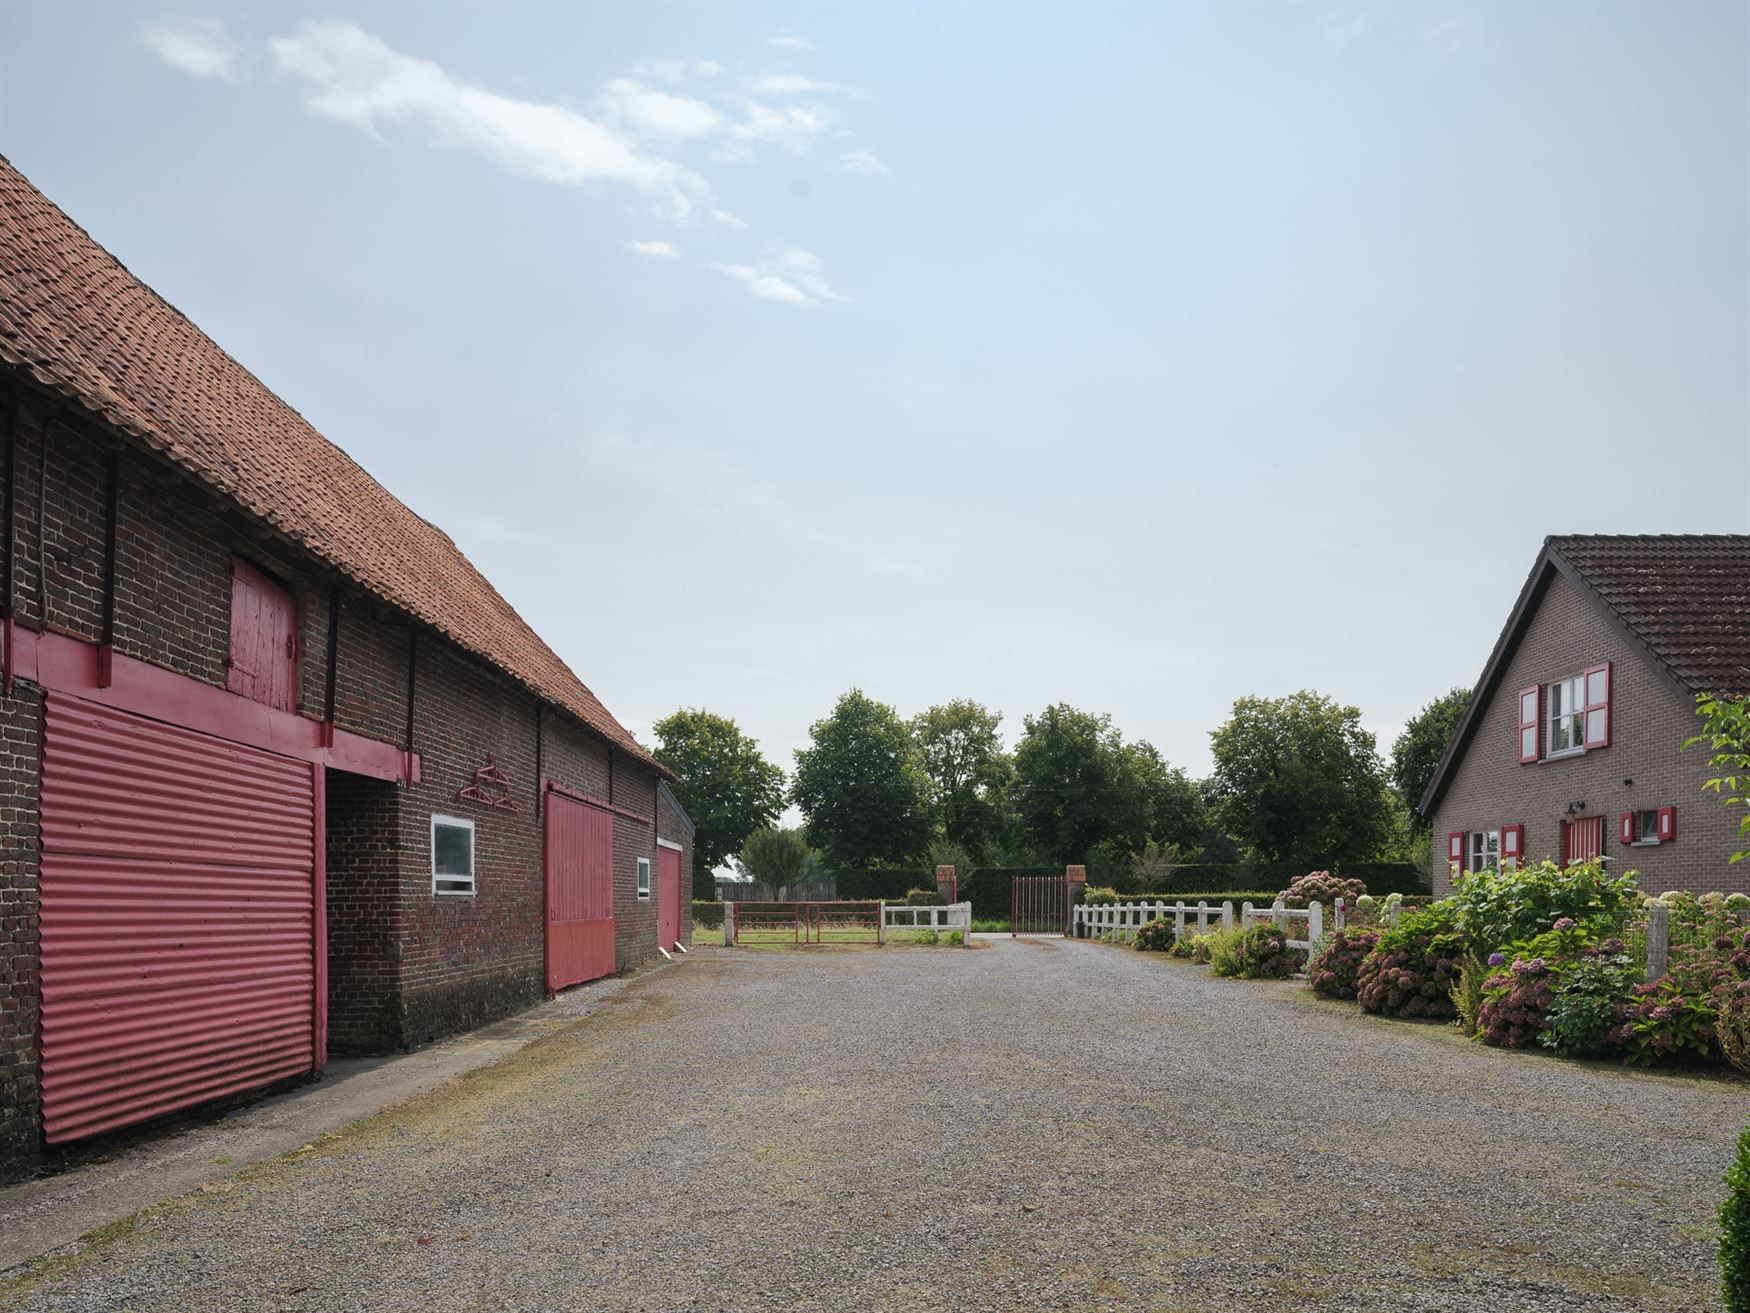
1015 702 1159 863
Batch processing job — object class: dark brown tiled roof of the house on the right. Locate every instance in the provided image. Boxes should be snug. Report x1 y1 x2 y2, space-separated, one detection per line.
1549 534 1750 697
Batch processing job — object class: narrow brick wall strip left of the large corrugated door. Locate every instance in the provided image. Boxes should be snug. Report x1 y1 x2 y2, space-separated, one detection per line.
0 683 42 1182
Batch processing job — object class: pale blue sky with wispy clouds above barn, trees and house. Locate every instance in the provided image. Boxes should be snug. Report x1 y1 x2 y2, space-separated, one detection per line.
0 0 1750 787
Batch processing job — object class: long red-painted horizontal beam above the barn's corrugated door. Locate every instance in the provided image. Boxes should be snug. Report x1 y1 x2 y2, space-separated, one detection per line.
4 625 420 784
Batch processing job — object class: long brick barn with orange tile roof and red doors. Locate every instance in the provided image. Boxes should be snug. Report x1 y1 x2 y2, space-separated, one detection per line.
0 159 691 1178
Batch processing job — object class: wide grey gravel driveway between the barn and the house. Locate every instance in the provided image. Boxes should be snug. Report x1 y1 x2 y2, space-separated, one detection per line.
0 940 1750 1313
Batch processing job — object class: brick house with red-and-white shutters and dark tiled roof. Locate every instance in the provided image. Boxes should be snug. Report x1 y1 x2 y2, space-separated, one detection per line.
1419 534 1750 895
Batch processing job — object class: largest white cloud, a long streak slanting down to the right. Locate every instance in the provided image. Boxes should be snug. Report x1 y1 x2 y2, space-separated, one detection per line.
270 19 711 219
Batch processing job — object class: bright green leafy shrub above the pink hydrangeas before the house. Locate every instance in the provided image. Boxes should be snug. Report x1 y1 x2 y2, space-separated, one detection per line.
1453 861 1642 952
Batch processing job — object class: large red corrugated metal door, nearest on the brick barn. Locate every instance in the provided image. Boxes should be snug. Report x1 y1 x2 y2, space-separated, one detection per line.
42 693 322 1141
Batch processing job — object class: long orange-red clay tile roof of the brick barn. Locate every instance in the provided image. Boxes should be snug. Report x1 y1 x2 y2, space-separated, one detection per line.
0 156 662 769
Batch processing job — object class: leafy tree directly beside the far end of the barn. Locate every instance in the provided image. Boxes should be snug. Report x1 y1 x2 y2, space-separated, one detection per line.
655 707 784 898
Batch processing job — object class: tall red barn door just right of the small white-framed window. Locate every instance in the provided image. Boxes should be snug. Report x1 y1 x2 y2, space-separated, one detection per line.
546 793 614 993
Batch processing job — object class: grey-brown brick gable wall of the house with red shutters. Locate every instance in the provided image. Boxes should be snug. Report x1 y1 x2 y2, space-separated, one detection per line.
1432 574 1750 895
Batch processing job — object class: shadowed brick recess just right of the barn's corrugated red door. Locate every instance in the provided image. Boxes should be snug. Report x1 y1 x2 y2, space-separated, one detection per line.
324 770 403 1054
